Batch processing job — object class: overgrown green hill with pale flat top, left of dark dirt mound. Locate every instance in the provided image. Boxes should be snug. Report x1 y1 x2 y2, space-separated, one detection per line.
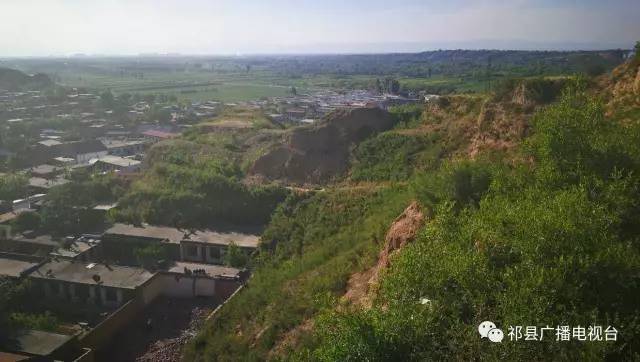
111 110 288 227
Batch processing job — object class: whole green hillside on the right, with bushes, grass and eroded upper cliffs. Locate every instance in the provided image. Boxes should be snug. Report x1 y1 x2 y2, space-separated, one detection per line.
185 58 640 361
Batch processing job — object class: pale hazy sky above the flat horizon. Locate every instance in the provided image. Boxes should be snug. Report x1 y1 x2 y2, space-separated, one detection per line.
0 0 640 56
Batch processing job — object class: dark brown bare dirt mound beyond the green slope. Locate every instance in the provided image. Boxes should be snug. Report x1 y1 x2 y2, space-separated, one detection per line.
249 108 393 184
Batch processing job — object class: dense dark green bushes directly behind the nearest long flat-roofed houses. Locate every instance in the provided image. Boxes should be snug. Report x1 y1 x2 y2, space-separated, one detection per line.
113 162 287 227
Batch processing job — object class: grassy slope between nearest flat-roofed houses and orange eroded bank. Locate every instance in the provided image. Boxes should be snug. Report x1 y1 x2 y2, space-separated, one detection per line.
185 187 410 361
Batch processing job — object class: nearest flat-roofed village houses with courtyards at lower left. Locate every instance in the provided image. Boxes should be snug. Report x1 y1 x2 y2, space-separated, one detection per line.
0 224 259 361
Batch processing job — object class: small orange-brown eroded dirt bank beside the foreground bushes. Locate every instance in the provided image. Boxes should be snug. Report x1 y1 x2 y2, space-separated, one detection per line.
343 201 426 307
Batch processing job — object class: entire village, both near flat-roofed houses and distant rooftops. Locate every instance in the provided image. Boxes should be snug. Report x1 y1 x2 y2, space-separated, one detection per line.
0 83 426 361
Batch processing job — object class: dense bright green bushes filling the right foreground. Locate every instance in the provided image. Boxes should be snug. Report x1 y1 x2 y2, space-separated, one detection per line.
309 84 640 361
